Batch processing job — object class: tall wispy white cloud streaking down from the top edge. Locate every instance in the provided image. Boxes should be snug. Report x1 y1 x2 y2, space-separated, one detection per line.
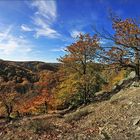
21 0 60 38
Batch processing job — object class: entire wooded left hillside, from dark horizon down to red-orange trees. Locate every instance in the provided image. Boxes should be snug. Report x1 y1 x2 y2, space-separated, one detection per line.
0 60 59 116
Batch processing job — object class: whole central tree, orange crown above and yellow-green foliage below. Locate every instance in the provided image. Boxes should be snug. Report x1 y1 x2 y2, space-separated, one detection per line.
59 34 104 104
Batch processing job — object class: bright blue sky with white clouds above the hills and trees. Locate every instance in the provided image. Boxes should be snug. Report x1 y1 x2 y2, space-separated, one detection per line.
0 0 140 62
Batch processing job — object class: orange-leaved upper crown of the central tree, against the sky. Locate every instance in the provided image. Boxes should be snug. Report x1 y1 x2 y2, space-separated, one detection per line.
59 34 100 63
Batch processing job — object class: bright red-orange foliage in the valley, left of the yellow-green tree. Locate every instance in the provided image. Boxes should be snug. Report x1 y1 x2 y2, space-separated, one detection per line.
18 70 59 114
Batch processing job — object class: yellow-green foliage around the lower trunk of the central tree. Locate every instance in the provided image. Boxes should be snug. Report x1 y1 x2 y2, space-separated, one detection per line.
55 63 105 108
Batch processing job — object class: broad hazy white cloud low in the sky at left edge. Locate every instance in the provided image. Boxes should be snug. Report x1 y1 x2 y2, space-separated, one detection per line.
0 26 33 56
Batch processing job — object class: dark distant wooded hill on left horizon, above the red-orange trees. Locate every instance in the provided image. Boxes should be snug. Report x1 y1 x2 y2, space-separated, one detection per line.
0 60 59 93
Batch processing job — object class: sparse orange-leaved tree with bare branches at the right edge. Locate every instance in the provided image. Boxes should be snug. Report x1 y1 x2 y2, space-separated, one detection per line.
98 15 140 81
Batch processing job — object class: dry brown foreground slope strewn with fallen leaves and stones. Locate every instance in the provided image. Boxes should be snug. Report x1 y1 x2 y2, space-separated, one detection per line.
0 87 140 140
